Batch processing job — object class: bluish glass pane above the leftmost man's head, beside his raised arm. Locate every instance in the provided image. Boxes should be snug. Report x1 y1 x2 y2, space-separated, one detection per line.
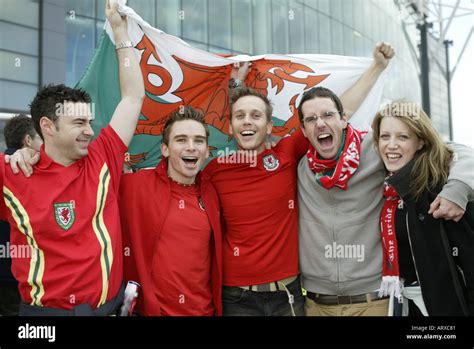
66 16 95 86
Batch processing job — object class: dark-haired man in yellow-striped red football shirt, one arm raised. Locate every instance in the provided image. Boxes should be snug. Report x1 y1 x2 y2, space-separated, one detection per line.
0 3 144 316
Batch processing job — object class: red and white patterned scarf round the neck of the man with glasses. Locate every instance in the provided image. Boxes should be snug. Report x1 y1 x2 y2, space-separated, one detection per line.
306 124 367 190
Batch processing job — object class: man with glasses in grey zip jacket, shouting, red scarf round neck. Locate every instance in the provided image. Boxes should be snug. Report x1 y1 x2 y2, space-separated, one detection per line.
298 88 474 316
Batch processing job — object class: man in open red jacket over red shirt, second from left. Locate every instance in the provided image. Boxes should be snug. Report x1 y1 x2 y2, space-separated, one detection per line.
119 107 222 316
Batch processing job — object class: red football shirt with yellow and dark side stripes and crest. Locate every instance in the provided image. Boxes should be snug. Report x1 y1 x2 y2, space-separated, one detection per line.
0 126 127 309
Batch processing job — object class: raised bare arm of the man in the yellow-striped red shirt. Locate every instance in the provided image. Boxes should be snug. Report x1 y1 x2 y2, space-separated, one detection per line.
105 0 145 145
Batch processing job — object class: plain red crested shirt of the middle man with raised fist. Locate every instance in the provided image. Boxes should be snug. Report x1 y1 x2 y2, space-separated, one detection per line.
204 130 308 286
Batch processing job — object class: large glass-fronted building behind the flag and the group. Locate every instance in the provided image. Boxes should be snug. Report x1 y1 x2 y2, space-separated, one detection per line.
0 0 433 148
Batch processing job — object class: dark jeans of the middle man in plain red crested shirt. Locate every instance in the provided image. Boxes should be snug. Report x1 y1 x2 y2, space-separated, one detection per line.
222 277 304 316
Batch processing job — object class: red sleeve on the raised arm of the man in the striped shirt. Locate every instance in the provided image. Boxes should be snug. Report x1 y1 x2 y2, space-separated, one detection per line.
89 125 127 191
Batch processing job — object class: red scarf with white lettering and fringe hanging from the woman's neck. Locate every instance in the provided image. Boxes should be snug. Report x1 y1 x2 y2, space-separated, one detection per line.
379 175 403 302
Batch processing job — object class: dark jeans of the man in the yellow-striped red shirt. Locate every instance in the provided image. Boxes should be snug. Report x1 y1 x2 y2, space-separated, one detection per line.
20 284 125 316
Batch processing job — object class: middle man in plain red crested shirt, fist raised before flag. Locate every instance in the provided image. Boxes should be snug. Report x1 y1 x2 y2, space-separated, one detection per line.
204 43 394 316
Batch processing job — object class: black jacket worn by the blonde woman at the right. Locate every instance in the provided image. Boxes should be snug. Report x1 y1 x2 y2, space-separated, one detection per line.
389 161 474 316
